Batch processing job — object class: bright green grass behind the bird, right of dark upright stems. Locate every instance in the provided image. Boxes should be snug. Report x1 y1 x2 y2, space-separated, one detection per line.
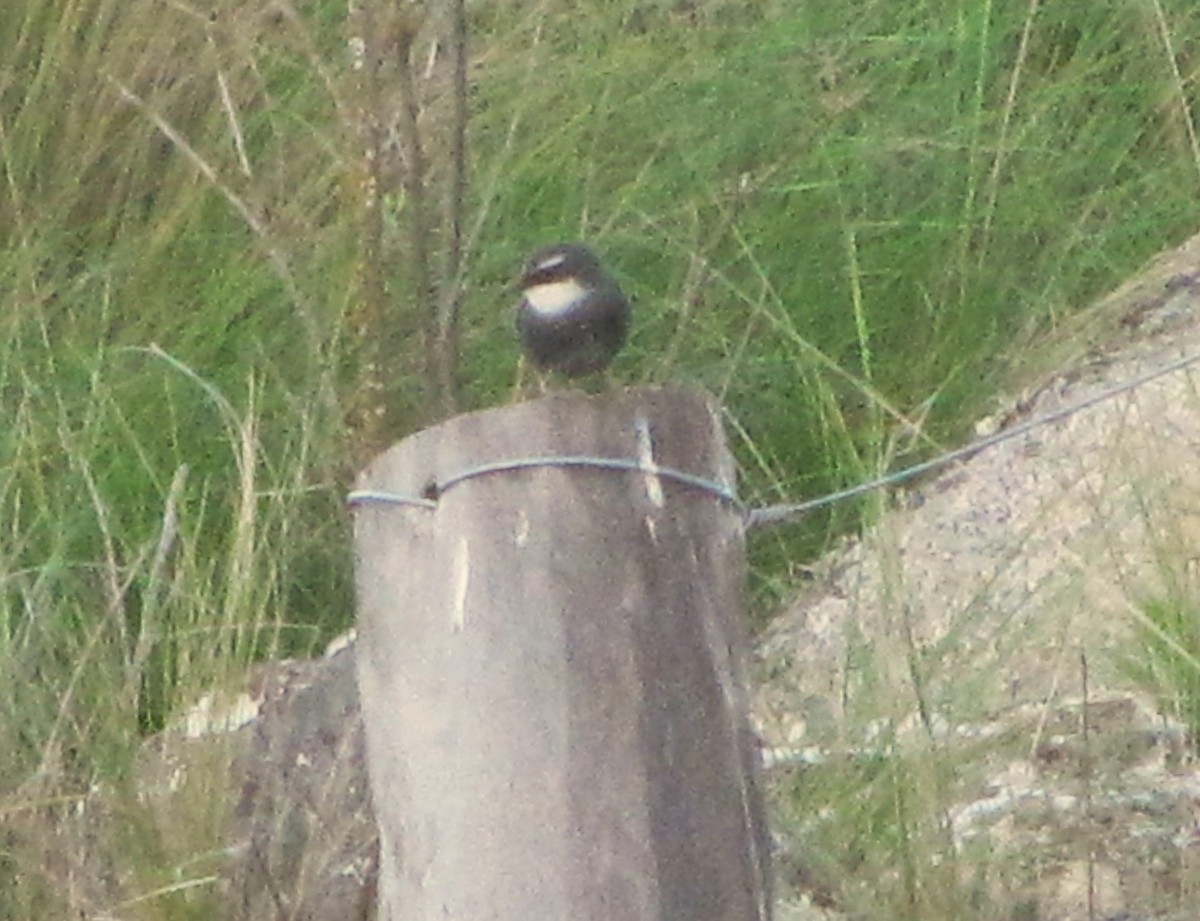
463 2 1200 597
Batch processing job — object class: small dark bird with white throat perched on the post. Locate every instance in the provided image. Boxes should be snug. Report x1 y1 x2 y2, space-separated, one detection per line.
517 243 629 378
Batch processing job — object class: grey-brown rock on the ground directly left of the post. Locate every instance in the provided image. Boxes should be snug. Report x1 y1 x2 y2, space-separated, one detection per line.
139 646 377 921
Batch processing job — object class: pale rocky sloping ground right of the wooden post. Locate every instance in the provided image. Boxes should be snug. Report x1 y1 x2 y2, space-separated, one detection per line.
756 232 1200 921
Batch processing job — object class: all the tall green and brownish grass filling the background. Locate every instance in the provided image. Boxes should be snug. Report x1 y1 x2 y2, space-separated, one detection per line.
0 0 1200 917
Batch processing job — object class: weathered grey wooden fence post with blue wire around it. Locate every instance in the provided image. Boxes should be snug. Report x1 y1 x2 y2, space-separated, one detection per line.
353 389 770 921
